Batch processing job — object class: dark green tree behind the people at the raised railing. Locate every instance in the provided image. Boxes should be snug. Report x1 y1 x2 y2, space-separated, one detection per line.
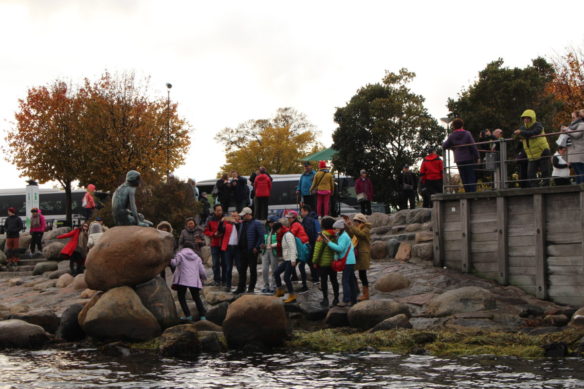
447 58 560 139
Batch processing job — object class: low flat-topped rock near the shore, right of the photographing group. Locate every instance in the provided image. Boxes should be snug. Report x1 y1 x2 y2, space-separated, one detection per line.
348 300 410 330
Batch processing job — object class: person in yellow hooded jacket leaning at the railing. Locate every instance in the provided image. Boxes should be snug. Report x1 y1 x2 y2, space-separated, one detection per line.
513 109 551 187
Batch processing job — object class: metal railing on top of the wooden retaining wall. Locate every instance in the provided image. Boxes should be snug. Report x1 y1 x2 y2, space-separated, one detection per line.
443 130 584 193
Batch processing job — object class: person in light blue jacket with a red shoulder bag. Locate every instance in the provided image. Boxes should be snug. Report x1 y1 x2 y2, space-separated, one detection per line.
325 220 357 306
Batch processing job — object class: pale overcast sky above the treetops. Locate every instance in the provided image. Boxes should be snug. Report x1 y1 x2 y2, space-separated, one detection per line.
0 0 584 189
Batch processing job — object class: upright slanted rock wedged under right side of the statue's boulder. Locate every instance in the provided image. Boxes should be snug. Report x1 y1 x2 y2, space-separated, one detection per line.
135 276 178 329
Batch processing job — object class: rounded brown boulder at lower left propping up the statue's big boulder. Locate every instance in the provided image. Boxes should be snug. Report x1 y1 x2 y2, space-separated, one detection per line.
79 284 160 340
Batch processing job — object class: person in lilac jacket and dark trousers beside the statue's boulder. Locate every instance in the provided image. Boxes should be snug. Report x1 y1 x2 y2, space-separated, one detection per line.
170 241 207 321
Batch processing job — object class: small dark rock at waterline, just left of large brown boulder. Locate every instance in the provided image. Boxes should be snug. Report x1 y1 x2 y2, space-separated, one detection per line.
158 324 201 359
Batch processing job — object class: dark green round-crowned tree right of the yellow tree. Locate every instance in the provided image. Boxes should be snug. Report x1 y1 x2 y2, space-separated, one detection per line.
333 69 445 206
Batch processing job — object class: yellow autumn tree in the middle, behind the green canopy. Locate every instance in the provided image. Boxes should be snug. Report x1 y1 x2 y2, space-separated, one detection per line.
215 108 319 174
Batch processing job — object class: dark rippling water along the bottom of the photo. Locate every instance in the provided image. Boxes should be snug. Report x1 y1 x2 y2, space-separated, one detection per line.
0 349 584 389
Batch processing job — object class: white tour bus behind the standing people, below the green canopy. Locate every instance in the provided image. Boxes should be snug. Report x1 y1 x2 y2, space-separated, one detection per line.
197 174 383 216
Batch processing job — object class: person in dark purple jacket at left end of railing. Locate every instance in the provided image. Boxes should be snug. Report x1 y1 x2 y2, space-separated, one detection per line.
442 118 479 192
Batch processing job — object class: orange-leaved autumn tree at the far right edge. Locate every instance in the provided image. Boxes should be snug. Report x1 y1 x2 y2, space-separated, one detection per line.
546 49 584 128
